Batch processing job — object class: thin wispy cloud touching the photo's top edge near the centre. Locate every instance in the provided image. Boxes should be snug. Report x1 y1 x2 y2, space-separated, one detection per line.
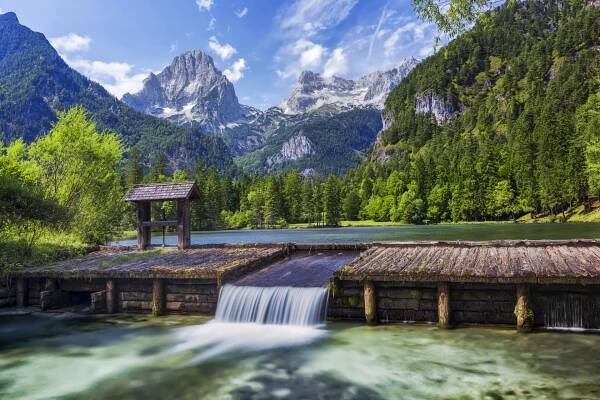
278 0 358 36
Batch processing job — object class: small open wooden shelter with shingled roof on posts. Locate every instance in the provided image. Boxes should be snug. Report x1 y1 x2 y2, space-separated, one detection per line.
125 181 199 250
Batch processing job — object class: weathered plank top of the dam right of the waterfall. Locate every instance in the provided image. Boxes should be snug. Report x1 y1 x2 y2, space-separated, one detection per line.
335 240 600 284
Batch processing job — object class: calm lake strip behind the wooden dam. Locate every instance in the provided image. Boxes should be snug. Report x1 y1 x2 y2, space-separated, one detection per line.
116 223 600 246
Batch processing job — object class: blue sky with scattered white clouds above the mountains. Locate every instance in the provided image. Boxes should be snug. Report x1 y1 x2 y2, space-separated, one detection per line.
0 0 437 109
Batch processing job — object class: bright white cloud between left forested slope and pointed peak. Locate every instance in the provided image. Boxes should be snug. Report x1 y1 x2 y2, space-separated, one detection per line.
62 55 148 98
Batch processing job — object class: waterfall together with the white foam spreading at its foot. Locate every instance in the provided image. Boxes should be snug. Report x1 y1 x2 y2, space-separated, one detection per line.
172 285 329 365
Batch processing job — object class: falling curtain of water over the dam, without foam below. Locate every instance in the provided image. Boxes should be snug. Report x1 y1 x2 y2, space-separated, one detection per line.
215 285 329 326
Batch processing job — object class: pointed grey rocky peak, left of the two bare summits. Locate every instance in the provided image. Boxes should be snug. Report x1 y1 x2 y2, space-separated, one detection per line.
122 50 243 131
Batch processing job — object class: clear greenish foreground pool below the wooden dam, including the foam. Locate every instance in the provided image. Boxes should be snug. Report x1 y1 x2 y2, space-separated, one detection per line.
0 316 600 400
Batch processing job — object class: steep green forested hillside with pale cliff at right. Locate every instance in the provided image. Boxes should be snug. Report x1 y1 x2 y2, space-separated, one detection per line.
348 1 600 222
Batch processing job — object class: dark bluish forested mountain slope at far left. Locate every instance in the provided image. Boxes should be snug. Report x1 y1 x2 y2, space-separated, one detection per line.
0 12 232 169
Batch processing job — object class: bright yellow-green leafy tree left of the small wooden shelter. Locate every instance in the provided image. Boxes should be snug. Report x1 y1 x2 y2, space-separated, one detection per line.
28 107 124 243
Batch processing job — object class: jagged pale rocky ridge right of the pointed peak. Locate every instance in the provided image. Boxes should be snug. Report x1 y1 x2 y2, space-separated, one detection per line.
279 58 419 114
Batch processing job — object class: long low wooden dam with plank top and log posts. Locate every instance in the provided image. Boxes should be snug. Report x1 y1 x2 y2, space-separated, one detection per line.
0 240 600 331
